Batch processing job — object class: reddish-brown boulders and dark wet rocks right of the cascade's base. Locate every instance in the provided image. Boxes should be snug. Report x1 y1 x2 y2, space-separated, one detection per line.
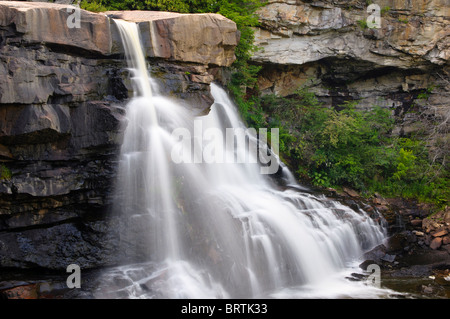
329 188 450 298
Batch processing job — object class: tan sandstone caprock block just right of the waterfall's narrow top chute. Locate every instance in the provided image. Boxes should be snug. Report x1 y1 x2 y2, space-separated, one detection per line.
108 11 239 66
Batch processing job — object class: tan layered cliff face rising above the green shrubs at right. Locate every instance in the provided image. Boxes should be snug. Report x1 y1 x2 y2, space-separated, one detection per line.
253 0 450 155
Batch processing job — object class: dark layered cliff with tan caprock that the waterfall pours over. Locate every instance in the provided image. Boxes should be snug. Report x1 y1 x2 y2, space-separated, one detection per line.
0 1 238 269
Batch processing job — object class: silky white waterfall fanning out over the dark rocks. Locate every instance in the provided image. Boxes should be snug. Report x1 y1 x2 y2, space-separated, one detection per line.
103 20 392 298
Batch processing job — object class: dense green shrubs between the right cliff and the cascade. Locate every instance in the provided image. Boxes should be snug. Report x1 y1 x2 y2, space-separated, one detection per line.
238 89 450 206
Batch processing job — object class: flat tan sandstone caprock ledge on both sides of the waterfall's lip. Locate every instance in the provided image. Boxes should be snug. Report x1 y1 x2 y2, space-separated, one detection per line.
0 1 239 66
